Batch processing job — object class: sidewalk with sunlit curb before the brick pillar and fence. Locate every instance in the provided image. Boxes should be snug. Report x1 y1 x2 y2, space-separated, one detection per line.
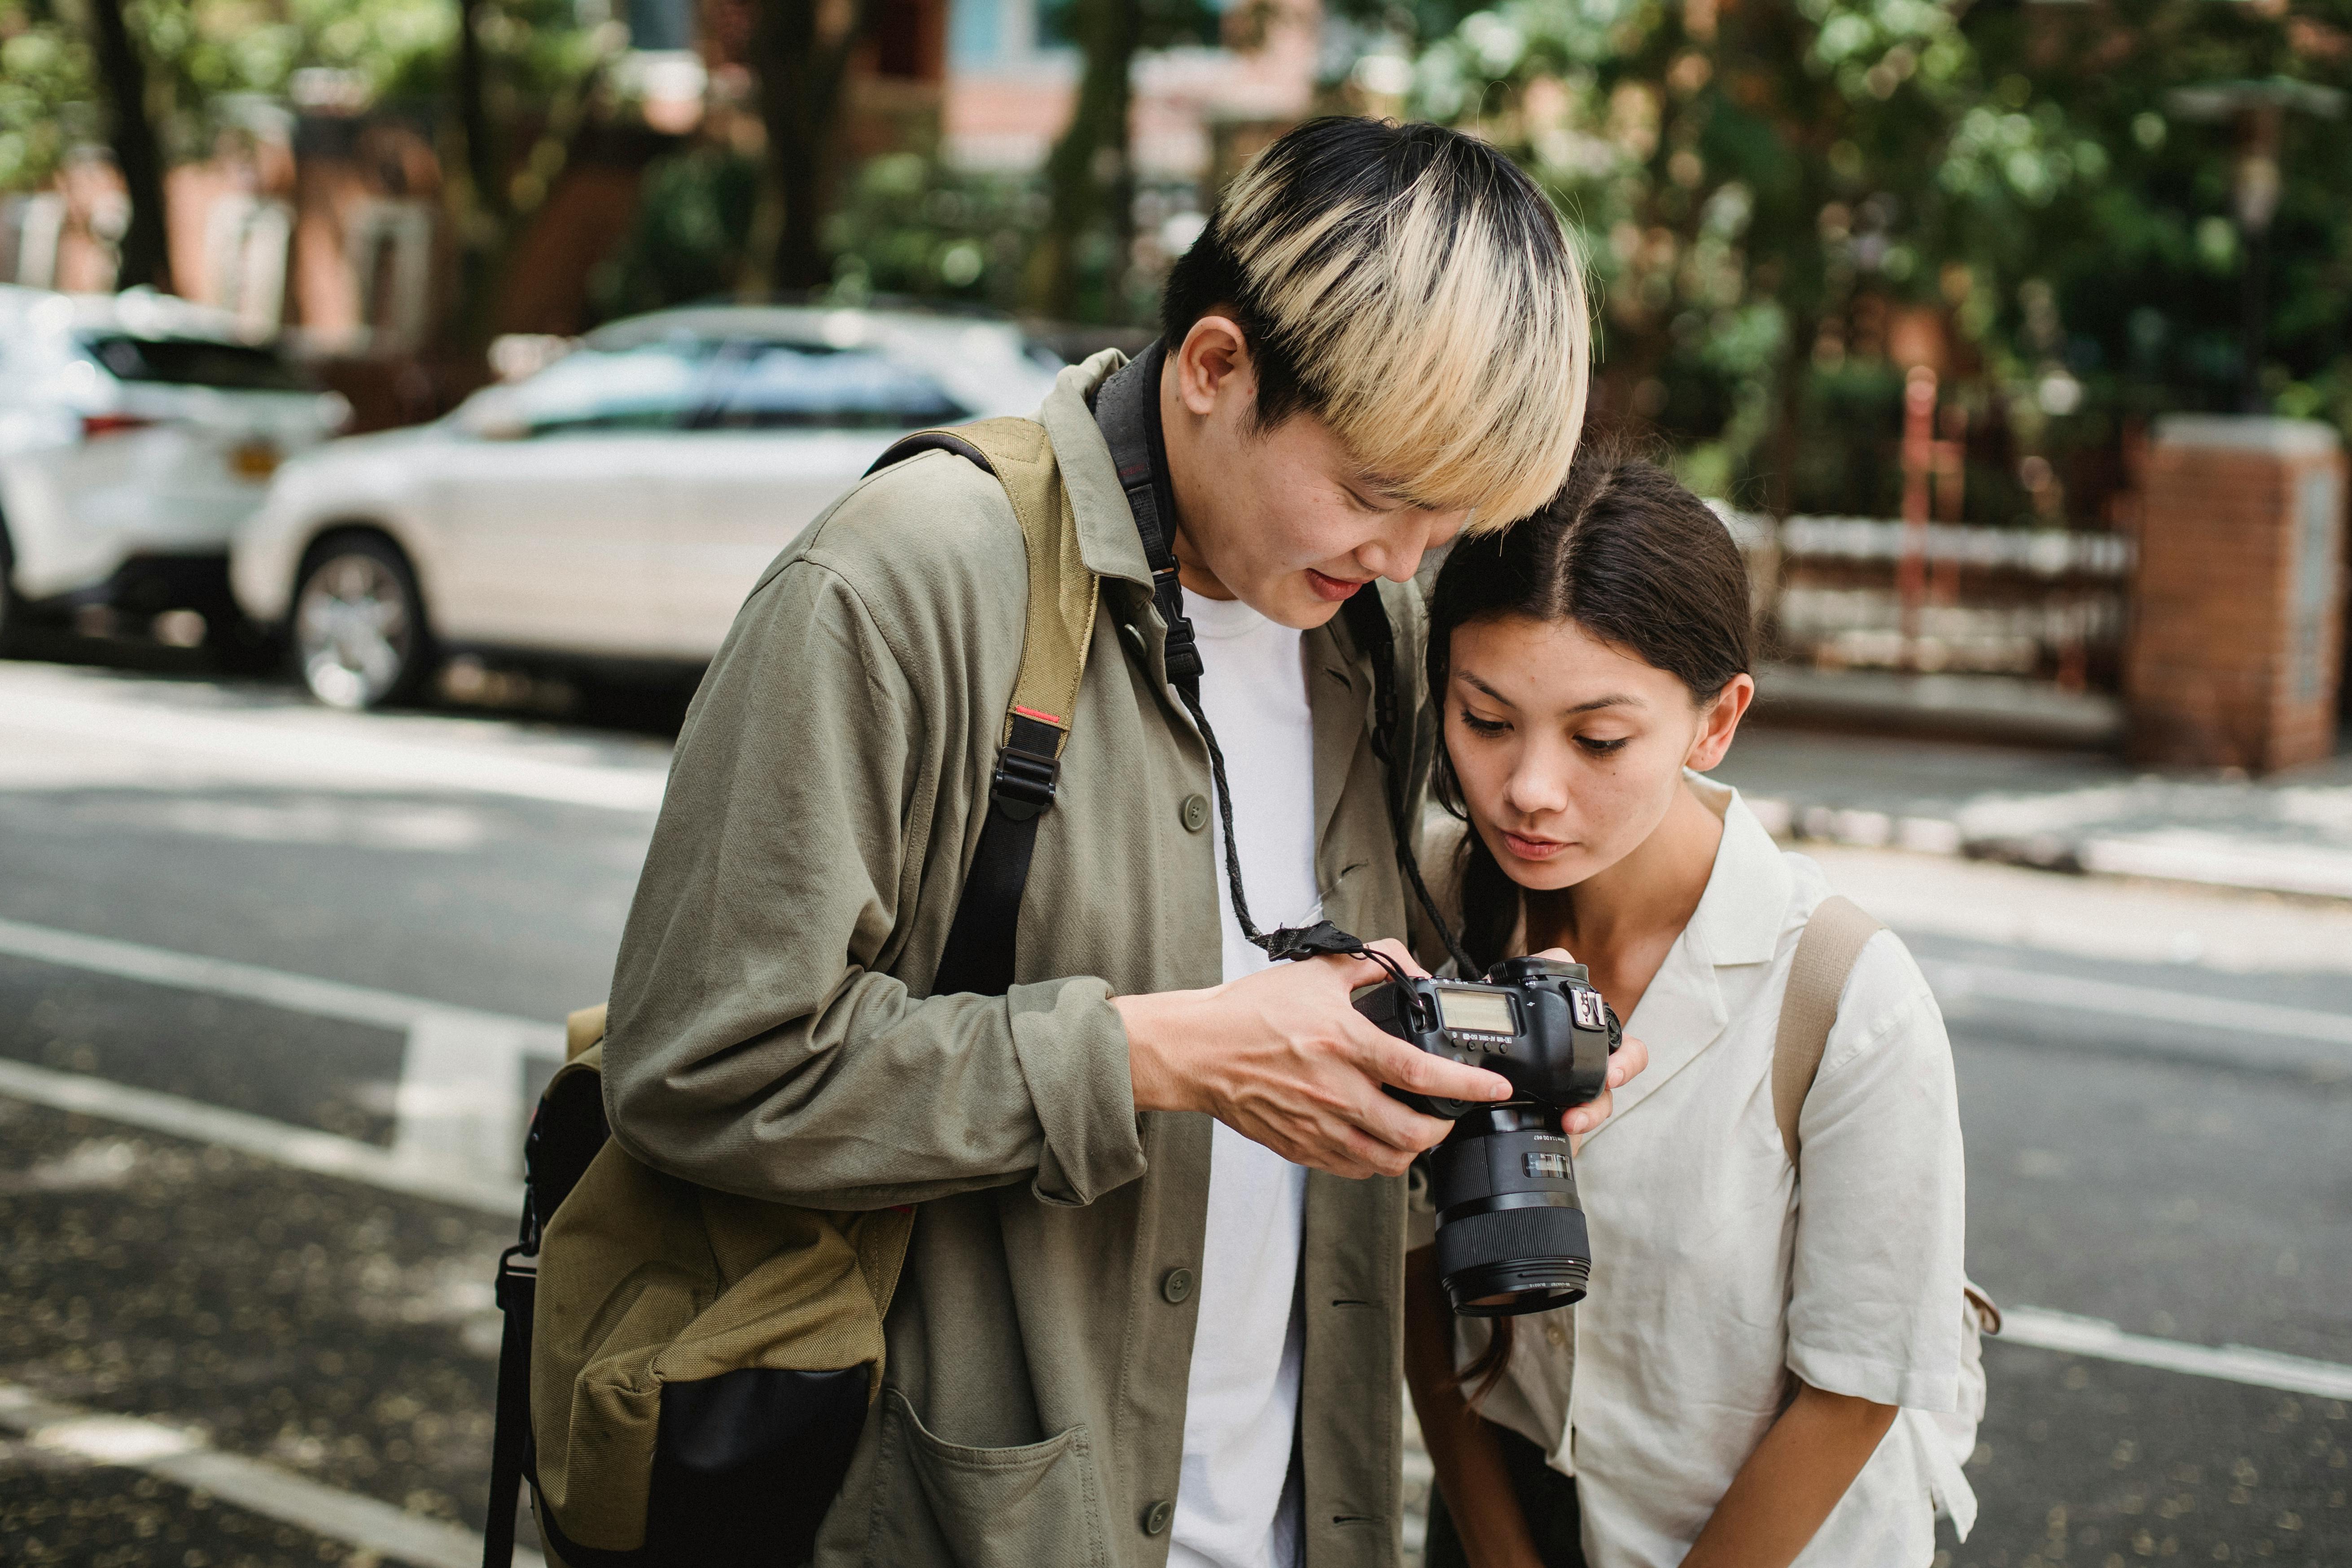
1715 727 2352 898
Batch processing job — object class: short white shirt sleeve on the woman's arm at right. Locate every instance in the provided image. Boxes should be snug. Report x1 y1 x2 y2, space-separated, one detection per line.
1787 931 1966 1410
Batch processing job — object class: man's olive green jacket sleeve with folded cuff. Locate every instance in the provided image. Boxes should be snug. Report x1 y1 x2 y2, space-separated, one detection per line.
604 560 1143 1209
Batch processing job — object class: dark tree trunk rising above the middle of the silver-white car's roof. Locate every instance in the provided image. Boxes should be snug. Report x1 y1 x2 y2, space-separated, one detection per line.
750 0 875 292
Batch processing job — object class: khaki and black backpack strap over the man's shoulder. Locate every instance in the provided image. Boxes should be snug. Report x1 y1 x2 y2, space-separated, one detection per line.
868 418 1101 997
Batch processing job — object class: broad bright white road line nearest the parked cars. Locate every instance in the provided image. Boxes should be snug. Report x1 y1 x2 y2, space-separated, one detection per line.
4 687 668 813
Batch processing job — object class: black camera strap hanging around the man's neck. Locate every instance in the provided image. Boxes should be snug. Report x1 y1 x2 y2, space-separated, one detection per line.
1094 341 1470 980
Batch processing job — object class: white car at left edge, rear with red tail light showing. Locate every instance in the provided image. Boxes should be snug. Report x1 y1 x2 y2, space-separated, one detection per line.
0 287 350 635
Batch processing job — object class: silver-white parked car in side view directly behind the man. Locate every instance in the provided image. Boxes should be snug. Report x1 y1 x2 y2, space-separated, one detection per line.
231 306 1058 708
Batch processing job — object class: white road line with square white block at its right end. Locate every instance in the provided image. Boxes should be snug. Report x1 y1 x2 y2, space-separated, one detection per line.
0 919 565 1175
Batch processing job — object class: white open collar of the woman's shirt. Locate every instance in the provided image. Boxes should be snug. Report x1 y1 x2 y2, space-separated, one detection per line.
1590 773 1795 1138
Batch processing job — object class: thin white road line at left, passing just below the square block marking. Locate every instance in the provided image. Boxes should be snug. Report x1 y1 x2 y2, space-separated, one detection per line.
0 1058 522 1220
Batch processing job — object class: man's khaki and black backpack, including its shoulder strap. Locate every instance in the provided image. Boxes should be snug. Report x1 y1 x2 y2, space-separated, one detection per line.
482 418 1099 1568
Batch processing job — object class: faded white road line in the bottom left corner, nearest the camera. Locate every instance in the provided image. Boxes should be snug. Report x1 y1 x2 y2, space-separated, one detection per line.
0 1382 546 1568
